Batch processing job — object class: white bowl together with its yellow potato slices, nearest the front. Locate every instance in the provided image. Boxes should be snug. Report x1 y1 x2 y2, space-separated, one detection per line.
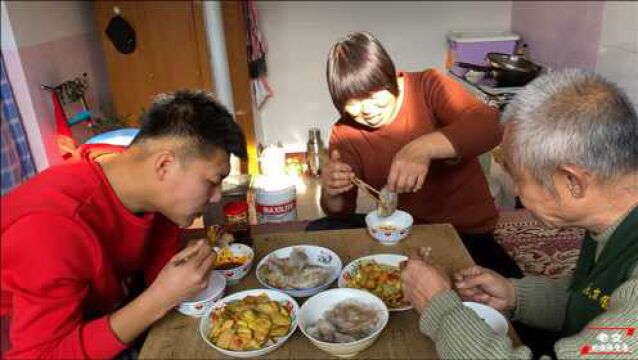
199 289 299 358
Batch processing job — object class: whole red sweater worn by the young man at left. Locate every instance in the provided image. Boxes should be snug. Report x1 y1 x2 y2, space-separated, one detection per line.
1 161 179 358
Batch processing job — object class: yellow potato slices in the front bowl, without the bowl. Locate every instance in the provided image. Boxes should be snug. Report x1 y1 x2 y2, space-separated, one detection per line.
208 294 292 351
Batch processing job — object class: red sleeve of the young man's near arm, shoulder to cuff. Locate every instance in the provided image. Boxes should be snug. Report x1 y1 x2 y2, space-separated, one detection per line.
2 215 127 358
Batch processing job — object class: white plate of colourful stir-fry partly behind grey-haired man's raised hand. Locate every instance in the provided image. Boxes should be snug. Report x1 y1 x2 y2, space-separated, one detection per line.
338 254 413 311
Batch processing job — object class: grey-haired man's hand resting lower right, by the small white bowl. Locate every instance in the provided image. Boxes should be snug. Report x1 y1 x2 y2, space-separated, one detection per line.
454 265 516 311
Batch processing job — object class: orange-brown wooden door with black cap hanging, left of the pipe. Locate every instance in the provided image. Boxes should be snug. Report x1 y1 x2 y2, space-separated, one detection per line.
95 1 213 125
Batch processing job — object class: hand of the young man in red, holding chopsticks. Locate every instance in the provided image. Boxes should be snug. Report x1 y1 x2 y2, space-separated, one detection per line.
148 240 216 311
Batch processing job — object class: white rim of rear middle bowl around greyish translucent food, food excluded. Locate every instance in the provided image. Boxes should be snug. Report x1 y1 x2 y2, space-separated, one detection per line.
257 245 343 297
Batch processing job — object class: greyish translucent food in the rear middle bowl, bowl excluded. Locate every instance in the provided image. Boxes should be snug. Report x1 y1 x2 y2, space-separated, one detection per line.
258 248 332 289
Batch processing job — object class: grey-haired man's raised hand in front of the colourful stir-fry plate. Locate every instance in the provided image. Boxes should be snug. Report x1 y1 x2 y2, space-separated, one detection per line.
401 249 452 314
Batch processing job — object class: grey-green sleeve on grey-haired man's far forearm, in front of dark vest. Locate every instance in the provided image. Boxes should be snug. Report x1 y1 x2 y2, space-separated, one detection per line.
510 276 571 331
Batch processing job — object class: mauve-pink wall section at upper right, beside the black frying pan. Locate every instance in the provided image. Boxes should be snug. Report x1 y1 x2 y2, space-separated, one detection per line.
511 1 604 70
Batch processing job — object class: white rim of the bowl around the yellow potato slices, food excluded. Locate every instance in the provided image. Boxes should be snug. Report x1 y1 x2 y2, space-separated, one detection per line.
199 289 299 358
